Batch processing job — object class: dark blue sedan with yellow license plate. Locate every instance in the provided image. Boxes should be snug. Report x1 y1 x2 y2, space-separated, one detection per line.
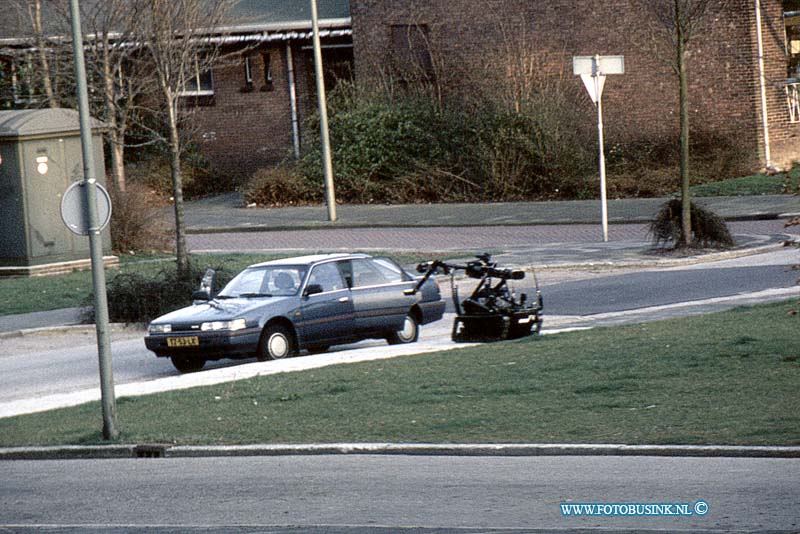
145 254 445 372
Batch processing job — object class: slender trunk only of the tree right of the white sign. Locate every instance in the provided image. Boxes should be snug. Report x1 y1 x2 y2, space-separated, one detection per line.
675 0 692 246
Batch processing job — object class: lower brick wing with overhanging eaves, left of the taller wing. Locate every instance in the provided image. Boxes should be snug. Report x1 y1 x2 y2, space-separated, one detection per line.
0 0 353 182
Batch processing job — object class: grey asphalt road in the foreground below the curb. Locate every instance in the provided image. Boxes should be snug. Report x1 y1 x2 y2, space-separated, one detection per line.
0 456 800 534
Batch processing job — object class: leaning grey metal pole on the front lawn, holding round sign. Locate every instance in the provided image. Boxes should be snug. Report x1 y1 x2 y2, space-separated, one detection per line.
70 0 119 440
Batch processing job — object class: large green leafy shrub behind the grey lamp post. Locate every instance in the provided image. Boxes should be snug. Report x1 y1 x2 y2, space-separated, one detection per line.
299 82 463 203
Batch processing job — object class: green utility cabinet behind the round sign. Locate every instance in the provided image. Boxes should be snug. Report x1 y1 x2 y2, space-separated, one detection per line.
0 109 111 275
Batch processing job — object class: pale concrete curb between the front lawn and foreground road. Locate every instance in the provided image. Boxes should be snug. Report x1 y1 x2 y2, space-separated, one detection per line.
0 443 800 461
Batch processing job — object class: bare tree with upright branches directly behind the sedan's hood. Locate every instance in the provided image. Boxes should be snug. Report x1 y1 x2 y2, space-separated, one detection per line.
134 0 233 274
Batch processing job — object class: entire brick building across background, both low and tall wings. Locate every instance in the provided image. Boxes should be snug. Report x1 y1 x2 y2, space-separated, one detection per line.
0 0 800 183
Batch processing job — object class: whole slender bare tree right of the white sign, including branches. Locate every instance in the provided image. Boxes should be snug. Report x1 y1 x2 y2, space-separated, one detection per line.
638 0 727 246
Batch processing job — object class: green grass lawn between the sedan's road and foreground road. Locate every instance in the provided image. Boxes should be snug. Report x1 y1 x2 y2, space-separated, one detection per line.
0 301 800 446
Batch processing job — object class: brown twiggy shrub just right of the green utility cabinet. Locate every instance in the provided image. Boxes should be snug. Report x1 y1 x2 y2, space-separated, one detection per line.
109 182 172 254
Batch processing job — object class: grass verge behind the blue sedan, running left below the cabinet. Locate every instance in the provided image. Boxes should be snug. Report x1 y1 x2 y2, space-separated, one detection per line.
0 252 460 315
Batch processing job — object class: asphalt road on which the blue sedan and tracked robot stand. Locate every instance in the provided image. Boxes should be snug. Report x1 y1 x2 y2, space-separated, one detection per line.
0 251 800 413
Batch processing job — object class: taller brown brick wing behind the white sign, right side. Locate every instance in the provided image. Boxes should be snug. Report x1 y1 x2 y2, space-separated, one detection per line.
350 0 800 168
